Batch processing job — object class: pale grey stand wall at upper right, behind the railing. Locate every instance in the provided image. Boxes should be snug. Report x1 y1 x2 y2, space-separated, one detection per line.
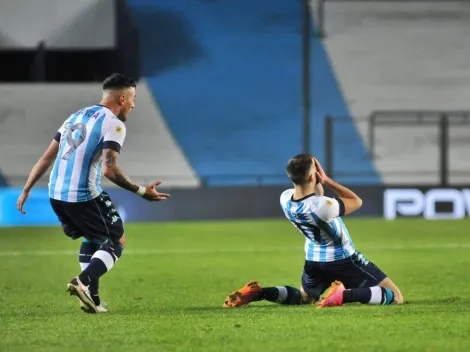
324 1 470 185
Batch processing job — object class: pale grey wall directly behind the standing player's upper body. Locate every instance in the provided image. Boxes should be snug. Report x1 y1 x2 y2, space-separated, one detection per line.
0 84 200 187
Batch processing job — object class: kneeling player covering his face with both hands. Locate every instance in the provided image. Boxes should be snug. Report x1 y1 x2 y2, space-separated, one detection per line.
224 154 403 308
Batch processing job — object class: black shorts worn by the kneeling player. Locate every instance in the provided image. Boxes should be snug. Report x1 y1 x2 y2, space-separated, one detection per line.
302 252 387 300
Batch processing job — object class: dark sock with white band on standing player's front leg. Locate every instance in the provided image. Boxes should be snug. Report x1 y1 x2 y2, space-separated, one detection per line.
78 244 122 286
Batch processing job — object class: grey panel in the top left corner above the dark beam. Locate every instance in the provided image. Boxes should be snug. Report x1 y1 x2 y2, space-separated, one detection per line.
0 0 116 50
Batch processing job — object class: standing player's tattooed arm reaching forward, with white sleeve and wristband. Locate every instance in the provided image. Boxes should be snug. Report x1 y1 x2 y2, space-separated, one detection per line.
102 120 170 201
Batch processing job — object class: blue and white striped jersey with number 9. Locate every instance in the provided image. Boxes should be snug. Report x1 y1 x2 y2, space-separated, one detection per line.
49 105 126 203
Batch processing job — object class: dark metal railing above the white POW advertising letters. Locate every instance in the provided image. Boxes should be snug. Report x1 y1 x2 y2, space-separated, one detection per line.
324 110 470 187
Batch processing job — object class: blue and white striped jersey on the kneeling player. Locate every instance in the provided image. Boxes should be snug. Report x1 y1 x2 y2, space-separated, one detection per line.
281 189 356 262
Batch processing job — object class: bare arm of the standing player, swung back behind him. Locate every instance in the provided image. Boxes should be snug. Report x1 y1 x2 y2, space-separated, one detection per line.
16 139 60 214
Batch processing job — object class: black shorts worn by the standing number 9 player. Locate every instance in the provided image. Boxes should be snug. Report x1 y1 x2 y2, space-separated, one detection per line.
50 192 124 243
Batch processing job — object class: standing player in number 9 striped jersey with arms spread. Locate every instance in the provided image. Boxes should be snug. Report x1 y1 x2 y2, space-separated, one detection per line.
17 74 169 313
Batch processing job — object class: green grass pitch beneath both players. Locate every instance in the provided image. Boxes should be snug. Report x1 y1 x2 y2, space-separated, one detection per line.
0 219 470 352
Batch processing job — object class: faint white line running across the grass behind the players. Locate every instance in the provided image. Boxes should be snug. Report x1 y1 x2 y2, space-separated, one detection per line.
0 243 470 257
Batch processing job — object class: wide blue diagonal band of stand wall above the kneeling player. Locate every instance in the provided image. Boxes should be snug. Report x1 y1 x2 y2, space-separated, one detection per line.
129 0 378 185
